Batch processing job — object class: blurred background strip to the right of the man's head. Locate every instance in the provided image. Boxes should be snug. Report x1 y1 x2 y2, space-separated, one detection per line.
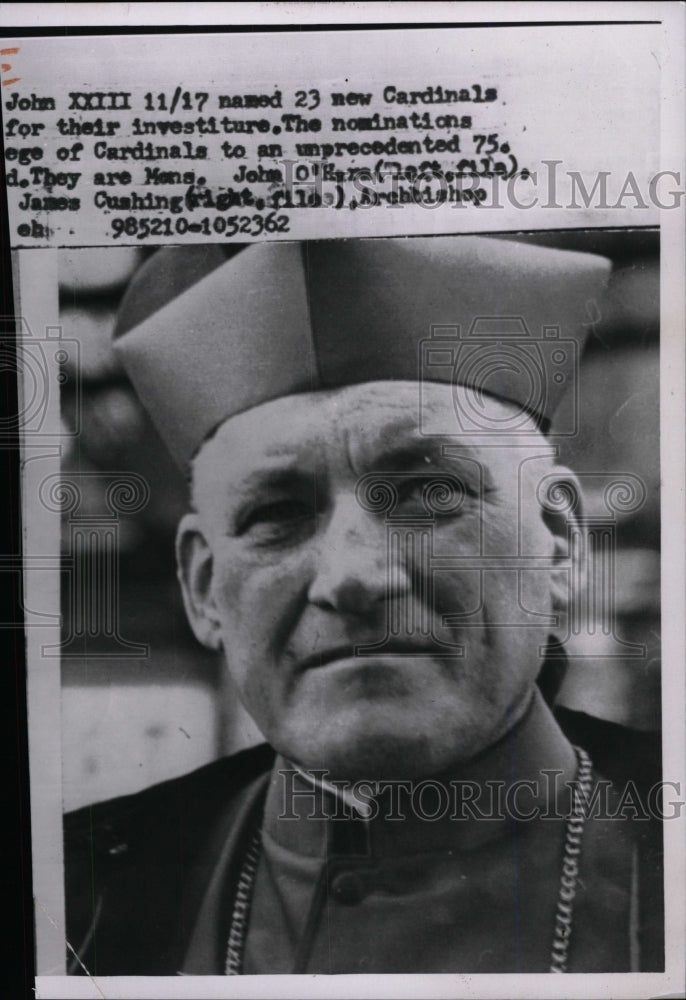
557 232 661 790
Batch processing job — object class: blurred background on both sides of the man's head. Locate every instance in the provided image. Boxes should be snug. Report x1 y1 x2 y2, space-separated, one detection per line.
60 231 660 809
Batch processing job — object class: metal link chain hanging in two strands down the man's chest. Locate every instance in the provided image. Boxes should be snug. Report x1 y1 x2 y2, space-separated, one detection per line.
224 746 593 976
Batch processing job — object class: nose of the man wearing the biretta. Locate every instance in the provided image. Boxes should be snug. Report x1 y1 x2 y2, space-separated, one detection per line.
308 496 411 617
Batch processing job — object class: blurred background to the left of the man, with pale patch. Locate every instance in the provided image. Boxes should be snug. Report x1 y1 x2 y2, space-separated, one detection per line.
60 247 257 810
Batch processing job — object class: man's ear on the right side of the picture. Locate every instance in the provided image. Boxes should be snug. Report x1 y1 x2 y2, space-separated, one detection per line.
542 465 585 640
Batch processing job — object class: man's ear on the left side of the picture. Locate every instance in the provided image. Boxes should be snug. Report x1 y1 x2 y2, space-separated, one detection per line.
176 514 221 649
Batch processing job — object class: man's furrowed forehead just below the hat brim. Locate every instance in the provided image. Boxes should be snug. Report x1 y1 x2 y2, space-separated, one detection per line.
194 381 544 482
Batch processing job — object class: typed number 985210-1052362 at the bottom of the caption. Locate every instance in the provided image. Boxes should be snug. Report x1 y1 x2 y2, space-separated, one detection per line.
110 212 290 240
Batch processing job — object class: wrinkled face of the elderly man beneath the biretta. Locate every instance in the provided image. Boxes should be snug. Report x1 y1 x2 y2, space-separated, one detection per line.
179 382 554 780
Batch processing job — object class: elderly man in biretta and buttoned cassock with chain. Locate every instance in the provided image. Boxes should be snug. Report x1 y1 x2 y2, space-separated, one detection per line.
66 237 662 975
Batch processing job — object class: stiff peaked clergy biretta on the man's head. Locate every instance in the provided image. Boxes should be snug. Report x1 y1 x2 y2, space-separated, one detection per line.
115 236 610 468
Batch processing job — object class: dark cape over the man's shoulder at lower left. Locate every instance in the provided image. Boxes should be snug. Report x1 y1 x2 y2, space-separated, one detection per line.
64 744 274 975
